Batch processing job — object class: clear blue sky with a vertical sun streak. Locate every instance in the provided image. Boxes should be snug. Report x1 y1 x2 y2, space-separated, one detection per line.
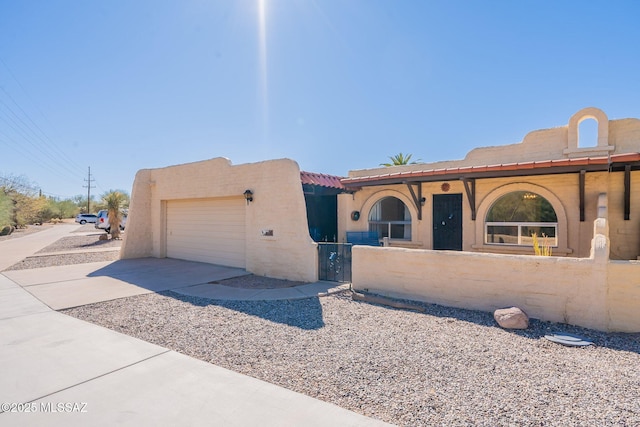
0 0 640 201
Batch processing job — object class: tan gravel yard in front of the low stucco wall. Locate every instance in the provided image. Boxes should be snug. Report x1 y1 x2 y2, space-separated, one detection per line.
65 285 640 426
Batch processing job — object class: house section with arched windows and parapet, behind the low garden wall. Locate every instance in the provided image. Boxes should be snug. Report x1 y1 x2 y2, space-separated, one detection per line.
338 108 640 259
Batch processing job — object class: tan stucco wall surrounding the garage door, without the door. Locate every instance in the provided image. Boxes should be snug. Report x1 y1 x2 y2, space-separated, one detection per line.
121 158 318 282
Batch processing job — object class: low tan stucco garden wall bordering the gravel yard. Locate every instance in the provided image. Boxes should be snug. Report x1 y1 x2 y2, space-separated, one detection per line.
352 219 640 332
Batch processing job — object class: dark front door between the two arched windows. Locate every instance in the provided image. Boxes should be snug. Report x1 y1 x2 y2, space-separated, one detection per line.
433 194 462 251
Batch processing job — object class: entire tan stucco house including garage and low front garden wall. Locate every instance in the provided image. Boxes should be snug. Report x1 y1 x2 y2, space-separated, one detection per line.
121 108 640 332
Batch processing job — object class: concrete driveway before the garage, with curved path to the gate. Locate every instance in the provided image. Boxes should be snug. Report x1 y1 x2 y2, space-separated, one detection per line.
0 258 349 310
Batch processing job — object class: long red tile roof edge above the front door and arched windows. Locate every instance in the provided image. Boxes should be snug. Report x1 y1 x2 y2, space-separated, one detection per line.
342 153 640 187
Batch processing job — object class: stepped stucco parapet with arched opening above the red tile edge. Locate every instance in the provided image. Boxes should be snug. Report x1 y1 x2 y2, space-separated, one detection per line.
348 107 640 178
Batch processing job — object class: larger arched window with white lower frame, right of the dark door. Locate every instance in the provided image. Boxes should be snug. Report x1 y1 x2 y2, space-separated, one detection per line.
485 191 558 246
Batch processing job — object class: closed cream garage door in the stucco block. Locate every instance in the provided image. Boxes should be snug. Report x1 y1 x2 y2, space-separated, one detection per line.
167 198 246 268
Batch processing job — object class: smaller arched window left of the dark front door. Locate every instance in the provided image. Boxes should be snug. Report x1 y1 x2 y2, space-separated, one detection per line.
369 197 411 240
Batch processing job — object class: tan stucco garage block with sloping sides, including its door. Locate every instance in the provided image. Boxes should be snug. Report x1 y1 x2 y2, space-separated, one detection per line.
120 158 318 282
